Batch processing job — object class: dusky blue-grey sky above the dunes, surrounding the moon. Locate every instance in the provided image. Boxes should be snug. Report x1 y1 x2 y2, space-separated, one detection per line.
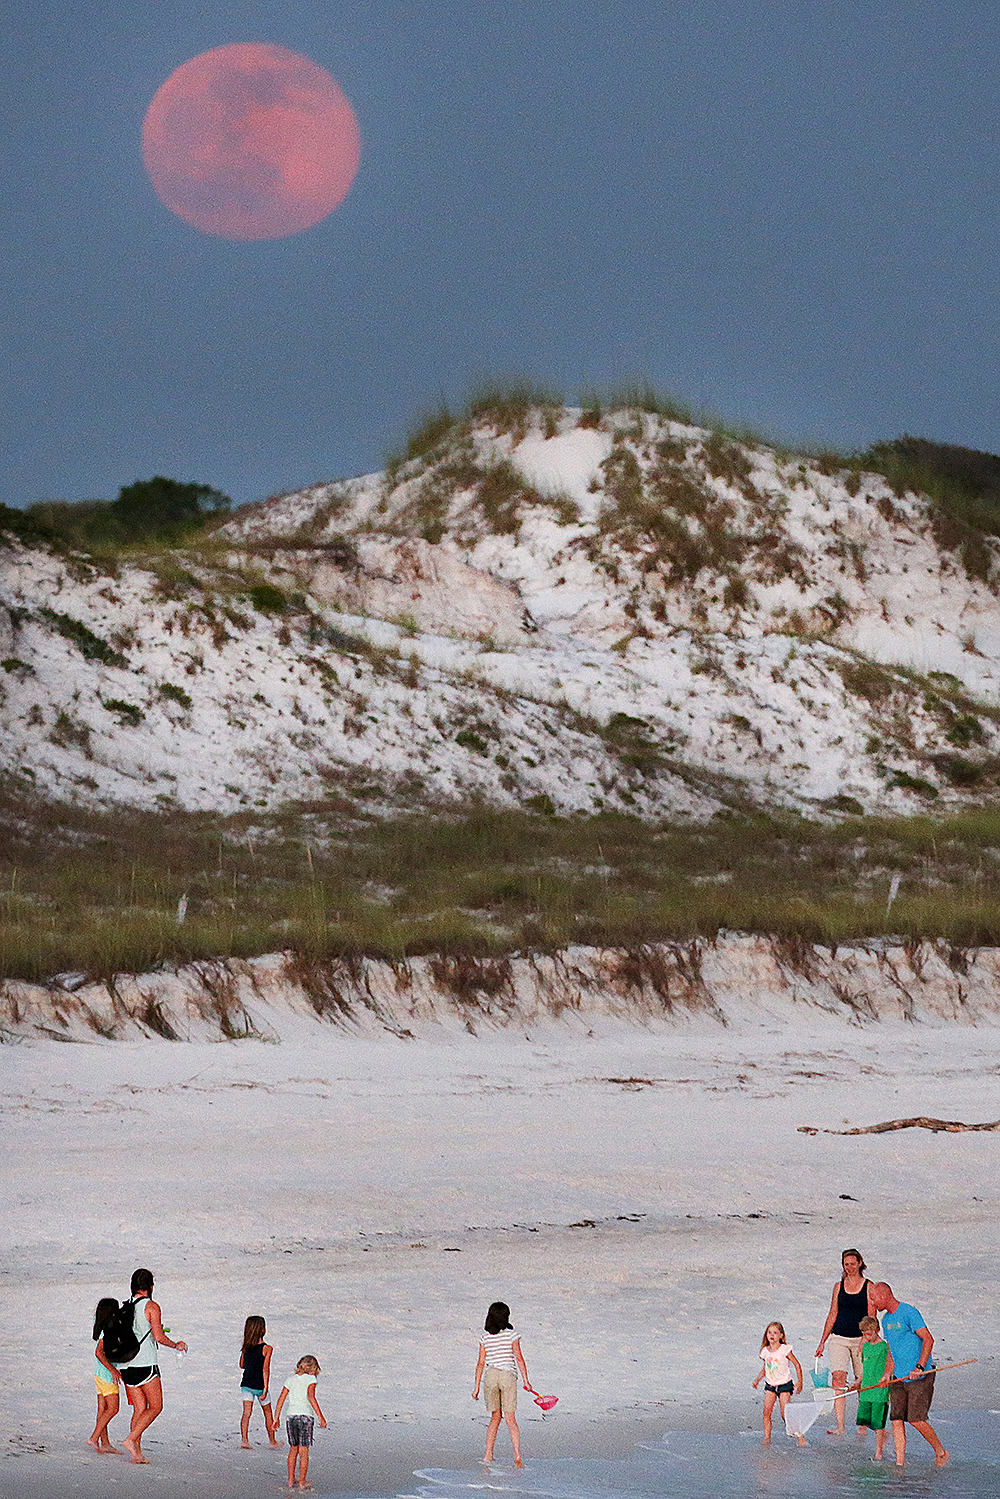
0 0 1000 505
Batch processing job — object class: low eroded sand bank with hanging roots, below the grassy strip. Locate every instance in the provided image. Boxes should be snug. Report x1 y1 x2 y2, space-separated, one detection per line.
0 934 1000 1043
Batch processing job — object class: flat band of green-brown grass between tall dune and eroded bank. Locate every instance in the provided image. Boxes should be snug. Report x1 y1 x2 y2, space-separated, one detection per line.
0 799 1000 980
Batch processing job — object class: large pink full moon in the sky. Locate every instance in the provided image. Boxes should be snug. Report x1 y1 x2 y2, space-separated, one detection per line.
142 42 361 240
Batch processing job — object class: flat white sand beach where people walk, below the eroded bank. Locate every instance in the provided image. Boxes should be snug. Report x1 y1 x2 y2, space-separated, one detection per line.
0 1013 1000 1499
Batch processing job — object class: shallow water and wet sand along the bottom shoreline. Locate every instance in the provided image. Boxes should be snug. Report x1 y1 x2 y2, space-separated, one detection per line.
0 1402 1000 1499
